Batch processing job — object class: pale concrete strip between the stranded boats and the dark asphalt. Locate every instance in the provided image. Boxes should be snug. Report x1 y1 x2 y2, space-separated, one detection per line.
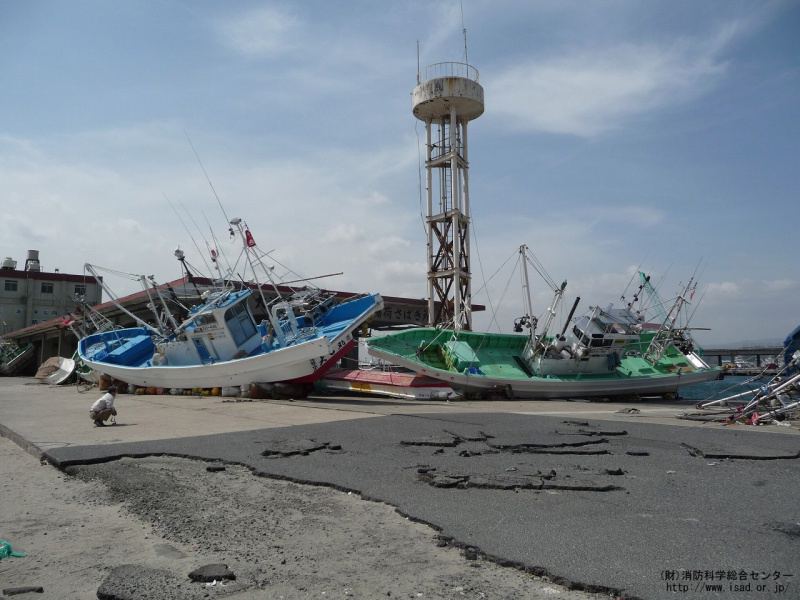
0 377 798 454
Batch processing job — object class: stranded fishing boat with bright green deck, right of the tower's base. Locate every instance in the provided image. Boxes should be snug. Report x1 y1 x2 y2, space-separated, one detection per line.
368 246 720 399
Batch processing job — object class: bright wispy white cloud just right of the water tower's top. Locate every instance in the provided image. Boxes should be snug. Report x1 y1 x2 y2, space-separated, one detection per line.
486 22 743 137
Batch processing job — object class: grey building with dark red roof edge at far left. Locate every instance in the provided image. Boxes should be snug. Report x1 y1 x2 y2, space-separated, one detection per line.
0 269 102 334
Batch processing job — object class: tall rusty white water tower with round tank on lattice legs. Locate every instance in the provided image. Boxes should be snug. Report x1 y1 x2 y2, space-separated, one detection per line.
411 62 483 331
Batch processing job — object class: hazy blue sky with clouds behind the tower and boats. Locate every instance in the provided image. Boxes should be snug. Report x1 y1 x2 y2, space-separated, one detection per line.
0 0 800 345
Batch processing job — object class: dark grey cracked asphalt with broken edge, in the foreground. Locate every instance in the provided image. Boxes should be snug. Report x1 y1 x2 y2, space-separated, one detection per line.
46 412 800 598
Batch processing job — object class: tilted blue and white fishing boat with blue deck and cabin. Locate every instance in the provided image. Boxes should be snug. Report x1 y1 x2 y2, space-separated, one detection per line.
78 219 383 388
